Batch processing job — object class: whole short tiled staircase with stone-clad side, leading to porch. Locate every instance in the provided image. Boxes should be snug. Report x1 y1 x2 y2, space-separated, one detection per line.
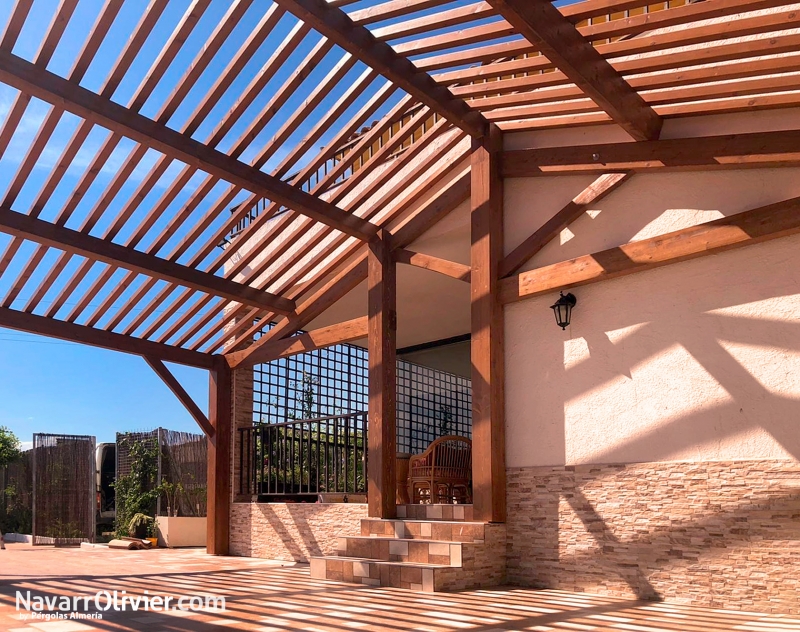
311 505 506 592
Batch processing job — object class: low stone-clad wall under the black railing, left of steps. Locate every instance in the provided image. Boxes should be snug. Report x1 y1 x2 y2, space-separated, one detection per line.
230 503 367 562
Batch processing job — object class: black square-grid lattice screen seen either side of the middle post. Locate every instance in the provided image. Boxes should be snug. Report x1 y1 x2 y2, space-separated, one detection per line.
253 326 472 453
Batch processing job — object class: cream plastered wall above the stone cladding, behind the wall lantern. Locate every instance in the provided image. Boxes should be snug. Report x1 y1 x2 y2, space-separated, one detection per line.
505 112 800 467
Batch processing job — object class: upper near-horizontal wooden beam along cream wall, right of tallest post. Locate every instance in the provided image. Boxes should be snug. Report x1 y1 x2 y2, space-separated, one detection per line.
501 130 800 178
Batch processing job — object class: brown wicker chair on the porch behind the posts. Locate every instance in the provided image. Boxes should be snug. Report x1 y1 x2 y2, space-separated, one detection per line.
408 435 472 504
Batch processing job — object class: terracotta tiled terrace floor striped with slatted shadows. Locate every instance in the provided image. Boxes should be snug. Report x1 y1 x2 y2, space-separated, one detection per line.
0 544 800 632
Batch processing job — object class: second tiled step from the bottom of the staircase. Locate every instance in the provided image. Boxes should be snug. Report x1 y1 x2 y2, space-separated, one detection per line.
337 536 462 567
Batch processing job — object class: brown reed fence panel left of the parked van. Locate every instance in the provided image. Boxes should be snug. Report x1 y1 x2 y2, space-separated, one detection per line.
32 434 95 545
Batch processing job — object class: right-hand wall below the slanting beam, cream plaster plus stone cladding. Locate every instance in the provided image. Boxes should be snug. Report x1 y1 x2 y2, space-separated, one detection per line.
506 228 800 614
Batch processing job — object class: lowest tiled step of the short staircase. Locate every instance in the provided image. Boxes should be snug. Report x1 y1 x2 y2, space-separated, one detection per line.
311 556 450 592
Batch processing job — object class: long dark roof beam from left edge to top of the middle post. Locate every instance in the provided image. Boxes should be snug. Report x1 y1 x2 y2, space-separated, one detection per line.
0 50 378 240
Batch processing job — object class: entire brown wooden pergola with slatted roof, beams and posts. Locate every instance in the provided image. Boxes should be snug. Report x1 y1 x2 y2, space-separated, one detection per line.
0 0 800 554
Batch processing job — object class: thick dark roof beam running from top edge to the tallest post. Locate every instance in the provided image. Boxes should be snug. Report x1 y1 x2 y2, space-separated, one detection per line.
276 0 488 136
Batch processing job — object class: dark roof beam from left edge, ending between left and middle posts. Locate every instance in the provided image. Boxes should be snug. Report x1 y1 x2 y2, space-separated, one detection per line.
0 206 295 314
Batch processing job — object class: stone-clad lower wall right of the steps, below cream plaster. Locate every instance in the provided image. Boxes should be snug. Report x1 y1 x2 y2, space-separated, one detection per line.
507 460 800 614
